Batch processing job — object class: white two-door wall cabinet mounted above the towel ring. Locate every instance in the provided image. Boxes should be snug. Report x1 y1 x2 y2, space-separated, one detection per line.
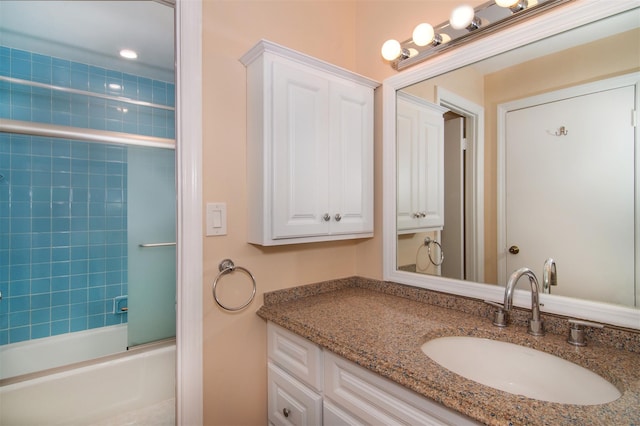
241 40 378 246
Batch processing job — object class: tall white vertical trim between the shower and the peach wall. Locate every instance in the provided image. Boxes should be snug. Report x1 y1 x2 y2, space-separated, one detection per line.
175 0 203 425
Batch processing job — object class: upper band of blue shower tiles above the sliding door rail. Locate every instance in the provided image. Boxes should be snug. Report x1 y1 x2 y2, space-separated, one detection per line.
0 46 175 139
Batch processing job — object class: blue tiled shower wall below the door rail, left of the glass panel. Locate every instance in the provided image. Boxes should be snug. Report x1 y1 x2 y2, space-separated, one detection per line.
0 133 127 344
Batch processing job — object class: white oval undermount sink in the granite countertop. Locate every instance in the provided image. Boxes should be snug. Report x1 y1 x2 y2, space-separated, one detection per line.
422 336 621 405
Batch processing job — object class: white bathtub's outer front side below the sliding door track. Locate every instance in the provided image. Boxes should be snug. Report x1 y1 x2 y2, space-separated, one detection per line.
0 326 176 426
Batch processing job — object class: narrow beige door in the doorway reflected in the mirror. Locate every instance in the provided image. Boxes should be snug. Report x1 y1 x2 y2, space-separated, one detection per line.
441 118 465 280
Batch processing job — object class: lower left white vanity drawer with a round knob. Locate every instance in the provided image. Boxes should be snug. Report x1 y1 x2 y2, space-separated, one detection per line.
268 362 322 426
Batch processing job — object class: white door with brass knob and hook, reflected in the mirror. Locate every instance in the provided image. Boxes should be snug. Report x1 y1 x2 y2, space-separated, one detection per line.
503 86 635 305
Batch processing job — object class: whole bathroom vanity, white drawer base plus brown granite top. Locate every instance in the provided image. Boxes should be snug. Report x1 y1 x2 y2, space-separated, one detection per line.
258 277 640 425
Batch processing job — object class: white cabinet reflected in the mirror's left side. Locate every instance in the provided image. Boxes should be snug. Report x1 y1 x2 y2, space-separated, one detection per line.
396 92 447 234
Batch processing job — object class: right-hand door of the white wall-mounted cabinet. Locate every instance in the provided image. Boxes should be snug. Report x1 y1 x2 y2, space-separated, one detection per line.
329 82 373 234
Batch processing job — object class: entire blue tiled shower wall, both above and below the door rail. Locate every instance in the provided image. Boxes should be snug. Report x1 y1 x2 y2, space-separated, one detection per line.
0 46 175 345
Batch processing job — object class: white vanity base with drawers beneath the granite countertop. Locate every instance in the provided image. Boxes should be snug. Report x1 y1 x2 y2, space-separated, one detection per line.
267 322 478 426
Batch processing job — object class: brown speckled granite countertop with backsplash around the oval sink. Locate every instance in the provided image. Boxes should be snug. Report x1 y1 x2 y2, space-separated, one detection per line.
258 277 640 425
